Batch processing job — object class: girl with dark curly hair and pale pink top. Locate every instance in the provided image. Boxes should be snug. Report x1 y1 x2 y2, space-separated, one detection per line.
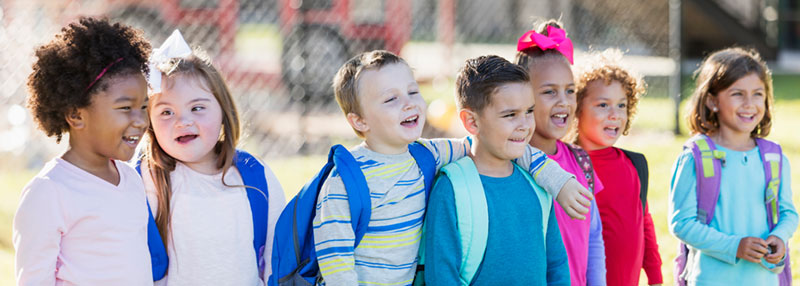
13 18 153 285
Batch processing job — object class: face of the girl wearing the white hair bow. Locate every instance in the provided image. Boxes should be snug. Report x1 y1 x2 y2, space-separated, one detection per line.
150 75 222 174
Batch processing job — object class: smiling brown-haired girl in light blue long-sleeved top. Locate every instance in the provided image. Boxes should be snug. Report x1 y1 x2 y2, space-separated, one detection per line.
669 48 798 285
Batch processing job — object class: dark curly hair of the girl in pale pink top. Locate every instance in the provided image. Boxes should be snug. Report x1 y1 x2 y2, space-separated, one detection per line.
28 17 151 142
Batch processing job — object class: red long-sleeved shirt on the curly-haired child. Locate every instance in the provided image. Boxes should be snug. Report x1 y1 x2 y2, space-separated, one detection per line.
589 147 663 286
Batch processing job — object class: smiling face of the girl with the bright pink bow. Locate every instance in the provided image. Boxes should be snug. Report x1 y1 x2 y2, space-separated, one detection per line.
530 59 578 143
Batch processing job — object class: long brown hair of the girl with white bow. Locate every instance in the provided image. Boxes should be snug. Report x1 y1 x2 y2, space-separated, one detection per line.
143 51 241 244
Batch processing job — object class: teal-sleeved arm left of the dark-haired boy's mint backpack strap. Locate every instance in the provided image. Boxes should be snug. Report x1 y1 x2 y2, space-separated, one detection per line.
425 175 461 285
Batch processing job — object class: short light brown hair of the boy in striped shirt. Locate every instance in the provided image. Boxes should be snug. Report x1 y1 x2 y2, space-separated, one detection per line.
333 50 407 138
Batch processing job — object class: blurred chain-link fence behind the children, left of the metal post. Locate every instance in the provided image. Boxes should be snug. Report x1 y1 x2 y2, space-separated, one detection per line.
0 0 669 168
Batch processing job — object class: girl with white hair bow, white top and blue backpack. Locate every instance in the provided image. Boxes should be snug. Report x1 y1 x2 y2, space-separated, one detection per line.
140 30 286 285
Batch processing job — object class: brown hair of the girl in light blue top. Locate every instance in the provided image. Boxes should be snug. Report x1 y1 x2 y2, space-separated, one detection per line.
686 47 774 138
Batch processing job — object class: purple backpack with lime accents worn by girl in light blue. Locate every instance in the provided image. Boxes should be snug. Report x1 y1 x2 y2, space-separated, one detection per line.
675 134 792 286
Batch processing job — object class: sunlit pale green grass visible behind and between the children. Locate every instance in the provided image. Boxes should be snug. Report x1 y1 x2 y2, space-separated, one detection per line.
0 98 800 285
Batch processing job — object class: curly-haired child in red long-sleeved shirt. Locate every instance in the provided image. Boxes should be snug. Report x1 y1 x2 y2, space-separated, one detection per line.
575 50 663 285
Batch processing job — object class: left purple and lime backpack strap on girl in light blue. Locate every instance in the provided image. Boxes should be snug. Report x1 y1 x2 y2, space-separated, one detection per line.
684 134 725 224
